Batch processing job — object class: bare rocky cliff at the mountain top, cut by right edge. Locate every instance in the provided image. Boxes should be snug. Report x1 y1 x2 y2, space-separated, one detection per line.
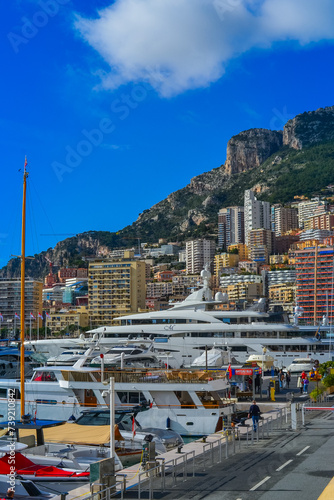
283 106 334 149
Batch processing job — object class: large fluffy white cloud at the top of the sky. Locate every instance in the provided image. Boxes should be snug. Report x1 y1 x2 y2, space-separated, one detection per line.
75 0 334 97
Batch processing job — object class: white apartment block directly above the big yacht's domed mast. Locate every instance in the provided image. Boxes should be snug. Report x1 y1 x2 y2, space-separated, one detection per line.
186 239 216 274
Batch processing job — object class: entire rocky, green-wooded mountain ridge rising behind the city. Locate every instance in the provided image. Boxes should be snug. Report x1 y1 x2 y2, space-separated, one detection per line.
0 106 334 279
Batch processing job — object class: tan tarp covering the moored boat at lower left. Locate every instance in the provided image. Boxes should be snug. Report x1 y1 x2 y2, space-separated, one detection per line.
19 422 123 446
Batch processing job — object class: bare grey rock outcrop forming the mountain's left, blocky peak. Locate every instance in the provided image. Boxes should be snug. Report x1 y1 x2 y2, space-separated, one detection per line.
225 128 283 176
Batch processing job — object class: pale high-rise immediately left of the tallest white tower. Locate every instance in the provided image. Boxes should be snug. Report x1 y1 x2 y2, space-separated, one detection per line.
218 207 245 249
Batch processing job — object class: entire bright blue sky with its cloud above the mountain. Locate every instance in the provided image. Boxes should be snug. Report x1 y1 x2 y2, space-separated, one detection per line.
0 0 334 265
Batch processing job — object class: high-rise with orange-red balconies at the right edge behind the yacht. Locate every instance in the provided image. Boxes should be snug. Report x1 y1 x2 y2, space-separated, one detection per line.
295 245 334 324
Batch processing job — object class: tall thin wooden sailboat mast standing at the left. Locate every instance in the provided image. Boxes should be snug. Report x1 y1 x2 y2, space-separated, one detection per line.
20 157 28 419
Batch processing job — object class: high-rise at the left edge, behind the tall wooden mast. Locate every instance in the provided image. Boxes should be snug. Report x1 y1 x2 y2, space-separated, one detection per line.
0 279 43 330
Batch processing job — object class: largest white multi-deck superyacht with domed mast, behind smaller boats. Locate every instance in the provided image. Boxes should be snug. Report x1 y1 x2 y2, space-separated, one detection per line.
28 270 334 367
